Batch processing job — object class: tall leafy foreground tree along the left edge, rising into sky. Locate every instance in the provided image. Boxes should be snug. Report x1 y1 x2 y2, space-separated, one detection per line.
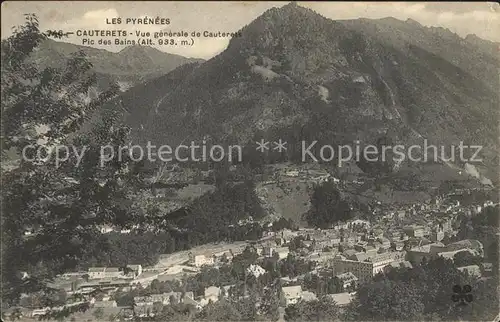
1 14 143 303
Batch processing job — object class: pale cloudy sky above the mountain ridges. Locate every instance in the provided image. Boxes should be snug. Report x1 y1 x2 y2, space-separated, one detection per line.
1 1 500 59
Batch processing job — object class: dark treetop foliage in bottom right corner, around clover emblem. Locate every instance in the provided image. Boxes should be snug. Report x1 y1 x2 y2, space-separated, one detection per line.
346 257 498 321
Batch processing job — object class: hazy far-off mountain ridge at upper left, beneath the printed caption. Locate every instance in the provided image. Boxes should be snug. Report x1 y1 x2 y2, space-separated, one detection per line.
32 39 203 90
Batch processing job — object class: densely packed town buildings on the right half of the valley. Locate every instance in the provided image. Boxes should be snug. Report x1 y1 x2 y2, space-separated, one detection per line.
250 195 494 304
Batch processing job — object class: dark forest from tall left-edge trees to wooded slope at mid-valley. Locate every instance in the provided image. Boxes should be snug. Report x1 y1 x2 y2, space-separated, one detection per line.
1 15 263 303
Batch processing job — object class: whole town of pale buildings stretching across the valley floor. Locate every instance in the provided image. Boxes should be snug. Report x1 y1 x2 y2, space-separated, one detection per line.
8 187 492 317
